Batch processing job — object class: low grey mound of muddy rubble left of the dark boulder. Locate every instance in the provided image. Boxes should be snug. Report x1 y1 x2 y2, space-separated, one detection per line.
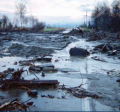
7 43 54 56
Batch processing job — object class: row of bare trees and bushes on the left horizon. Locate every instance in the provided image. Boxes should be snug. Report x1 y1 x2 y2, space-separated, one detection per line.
0 0 45 32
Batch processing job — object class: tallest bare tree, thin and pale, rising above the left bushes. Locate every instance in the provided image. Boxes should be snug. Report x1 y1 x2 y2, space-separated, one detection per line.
16 1 26 27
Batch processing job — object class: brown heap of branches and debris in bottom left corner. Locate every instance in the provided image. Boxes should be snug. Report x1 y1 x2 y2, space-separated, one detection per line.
0 99 28 111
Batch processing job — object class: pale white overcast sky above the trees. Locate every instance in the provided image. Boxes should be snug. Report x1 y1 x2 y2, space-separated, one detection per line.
0 0 112 24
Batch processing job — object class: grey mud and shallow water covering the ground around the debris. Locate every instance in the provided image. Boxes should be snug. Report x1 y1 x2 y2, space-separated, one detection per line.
0 30 120 111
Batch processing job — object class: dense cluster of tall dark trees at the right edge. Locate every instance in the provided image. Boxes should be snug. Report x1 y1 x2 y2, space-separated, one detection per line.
89 0 120 32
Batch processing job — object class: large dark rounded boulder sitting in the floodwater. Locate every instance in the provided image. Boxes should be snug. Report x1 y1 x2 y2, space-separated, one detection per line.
69 47 90 57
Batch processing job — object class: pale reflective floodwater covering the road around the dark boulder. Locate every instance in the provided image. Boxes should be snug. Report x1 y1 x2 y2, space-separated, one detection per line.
0 32 120 111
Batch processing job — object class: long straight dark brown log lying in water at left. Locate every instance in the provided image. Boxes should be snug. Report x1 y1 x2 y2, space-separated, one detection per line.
1 79 59 87
